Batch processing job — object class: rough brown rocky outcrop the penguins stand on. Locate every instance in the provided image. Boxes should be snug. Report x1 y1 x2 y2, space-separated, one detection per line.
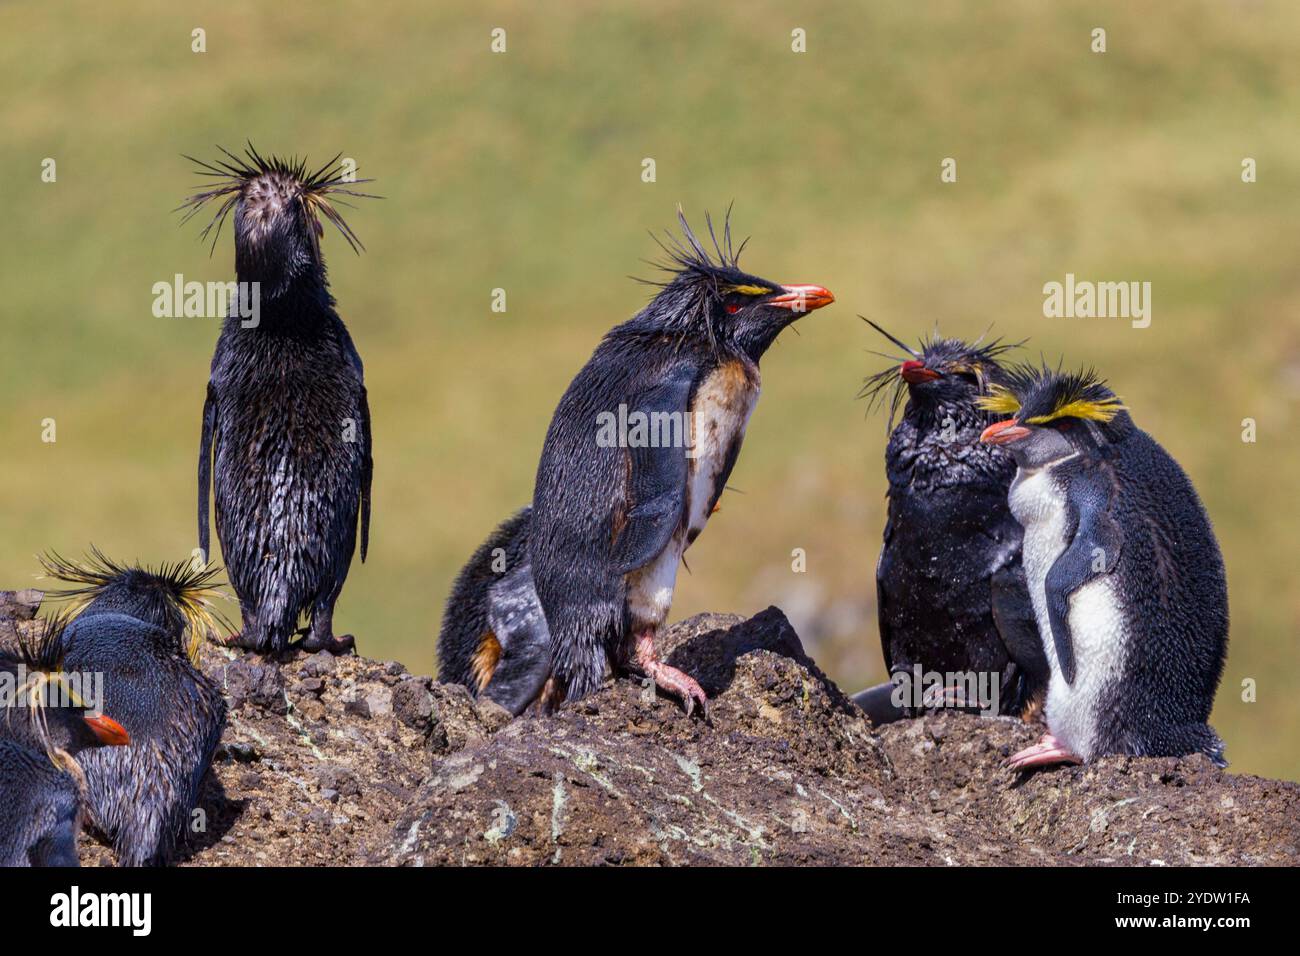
0 597 1300 866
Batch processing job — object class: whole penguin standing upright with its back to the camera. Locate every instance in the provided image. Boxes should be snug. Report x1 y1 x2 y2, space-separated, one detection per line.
182 144 373 656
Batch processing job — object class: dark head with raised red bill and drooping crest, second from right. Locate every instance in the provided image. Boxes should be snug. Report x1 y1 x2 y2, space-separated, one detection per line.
858 316 1021 429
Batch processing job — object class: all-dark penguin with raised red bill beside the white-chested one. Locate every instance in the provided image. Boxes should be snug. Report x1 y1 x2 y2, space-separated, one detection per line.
854 319 1048 723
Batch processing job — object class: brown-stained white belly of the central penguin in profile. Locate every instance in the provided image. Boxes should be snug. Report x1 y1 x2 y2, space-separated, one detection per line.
628 362 759 628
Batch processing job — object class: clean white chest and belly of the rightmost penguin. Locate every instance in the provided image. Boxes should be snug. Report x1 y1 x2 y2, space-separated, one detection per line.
1008 467 1127 760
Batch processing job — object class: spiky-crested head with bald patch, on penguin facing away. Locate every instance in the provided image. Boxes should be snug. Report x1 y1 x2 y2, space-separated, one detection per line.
181 143 373 297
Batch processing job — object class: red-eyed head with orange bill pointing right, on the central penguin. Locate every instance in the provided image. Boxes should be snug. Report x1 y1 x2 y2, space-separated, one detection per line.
632 208 835 362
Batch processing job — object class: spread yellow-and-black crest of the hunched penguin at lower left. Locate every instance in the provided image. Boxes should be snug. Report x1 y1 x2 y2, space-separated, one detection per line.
39 545 234 665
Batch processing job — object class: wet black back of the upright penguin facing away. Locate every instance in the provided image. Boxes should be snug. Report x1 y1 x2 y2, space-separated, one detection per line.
209 304 369 652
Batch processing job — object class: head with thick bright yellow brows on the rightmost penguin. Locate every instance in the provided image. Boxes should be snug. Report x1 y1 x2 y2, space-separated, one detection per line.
979 365 1132 470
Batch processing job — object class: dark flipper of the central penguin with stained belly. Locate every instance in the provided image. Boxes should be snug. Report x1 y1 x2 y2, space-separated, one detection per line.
611 364 694 574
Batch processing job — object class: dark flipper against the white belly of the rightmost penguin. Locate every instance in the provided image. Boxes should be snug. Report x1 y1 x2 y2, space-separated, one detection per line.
1044 475 1125 684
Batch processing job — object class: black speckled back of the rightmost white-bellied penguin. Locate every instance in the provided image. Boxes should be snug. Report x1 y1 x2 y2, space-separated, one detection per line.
1097 427 1229 763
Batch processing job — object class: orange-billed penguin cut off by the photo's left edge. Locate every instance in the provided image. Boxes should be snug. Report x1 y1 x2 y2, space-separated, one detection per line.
0 617 130 866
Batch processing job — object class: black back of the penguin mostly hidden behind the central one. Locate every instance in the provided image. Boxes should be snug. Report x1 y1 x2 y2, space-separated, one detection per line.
438 507 532 692
